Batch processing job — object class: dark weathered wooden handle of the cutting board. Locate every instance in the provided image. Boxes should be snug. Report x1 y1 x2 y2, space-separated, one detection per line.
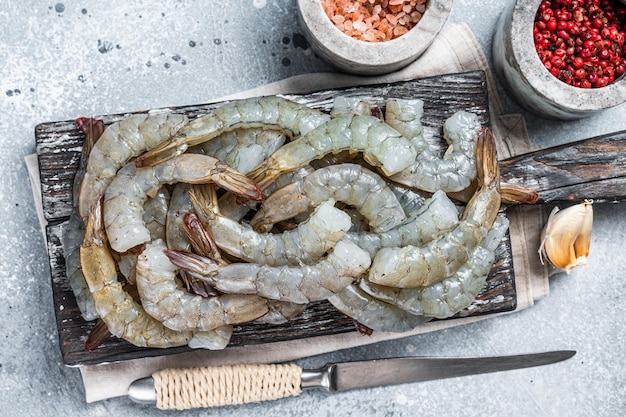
500 131 626 203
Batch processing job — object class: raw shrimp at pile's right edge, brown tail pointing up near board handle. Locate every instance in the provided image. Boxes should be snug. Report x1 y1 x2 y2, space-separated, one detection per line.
368 129 500 288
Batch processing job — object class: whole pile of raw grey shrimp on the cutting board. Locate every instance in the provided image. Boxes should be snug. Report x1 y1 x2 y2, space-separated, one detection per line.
64 96 508 349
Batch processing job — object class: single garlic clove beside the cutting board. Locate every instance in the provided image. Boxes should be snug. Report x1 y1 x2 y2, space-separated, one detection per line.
539 200 593 274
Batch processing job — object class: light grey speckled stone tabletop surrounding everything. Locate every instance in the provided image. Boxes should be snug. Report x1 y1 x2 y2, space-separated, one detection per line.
0 0 626 417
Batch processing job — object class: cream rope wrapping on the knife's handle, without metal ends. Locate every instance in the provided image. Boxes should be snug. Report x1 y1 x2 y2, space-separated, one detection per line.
152 365 302 410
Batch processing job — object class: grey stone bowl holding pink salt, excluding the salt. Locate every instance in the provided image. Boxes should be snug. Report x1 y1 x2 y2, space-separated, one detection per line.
298 0 453 75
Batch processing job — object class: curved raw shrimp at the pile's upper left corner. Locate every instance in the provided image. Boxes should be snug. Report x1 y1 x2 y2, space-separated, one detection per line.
79 112 188 219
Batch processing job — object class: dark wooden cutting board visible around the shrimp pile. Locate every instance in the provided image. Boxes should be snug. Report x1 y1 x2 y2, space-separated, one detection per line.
35 71 623 365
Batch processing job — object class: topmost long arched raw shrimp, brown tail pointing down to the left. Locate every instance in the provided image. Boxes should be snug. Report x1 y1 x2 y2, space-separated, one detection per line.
136 96 330 166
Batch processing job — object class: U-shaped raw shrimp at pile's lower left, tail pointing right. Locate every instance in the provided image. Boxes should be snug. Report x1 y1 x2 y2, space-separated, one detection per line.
137 239 269 331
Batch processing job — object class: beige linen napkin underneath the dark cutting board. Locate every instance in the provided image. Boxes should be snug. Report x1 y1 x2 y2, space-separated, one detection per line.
27 24 548 402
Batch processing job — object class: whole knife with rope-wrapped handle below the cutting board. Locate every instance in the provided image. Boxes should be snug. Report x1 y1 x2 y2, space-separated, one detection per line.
128 350 576 410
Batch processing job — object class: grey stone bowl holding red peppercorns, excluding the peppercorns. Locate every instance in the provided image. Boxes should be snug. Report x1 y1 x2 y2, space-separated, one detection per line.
492 0 626 120
